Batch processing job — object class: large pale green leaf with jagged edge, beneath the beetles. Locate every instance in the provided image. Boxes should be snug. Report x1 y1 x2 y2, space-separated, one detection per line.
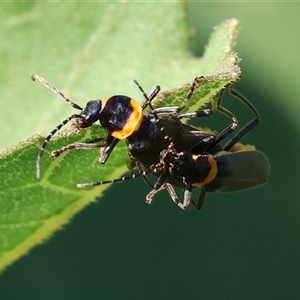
0 2 240 270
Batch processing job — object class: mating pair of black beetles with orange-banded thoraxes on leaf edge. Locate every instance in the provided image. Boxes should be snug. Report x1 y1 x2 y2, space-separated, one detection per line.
32 74 270 209
